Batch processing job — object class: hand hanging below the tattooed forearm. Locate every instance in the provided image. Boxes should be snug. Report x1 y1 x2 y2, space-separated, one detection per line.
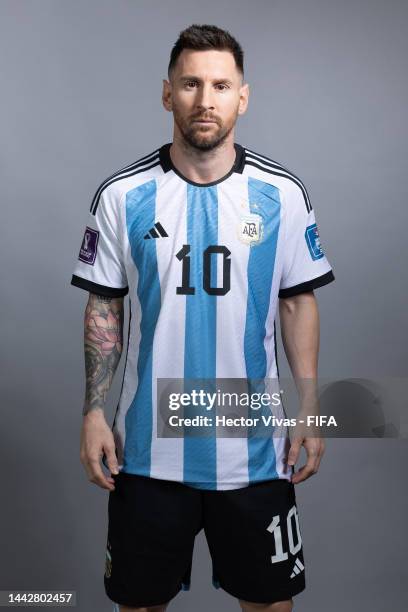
80 408 119 491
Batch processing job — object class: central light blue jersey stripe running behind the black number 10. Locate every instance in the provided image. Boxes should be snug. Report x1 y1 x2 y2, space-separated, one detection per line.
184 184 218 489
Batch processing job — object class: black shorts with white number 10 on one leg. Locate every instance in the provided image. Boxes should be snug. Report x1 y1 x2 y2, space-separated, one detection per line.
104 472 305 607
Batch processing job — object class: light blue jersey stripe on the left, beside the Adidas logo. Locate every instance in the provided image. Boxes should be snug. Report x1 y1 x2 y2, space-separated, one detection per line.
123 180 161 476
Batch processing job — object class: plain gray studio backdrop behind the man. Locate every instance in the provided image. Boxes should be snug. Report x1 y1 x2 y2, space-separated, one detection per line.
0 0 408 612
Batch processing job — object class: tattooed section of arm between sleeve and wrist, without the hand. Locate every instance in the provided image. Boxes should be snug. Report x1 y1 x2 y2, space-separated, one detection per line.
83 293 124 415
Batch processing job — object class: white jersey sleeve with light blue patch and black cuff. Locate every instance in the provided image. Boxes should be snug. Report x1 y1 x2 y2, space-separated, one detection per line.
279 184 335 298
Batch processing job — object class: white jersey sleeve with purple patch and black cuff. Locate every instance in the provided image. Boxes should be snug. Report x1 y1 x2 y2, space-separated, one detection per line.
71 183 129 297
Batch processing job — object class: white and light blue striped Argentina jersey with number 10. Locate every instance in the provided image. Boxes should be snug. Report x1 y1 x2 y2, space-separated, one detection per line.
71 143 334 490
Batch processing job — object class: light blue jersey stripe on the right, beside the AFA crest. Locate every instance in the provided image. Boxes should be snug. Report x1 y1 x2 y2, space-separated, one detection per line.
244 178 280 482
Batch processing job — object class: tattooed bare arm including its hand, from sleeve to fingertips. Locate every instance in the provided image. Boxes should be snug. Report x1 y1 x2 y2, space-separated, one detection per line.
80 293 124 491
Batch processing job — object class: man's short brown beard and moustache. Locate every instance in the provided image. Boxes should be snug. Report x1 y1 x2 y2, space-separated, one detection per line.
173 103 238 151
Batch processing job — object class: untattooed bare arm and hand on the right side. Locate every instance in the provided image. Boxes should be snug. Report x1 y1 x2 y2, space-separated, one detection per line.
279 291 325 484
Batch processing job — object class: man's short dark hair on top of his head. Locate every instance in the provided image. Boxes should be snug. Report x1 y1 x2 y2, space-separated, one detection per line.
168 23 244 78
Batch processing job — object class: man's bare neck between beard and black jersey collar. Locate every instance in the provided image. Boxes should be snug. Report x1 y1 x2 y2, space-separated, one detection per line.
170 132 236 183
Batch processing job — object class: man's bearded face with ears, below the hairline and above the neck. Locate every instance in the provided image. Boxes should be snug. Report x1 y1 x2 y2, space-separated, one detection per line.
163 49 249 151
